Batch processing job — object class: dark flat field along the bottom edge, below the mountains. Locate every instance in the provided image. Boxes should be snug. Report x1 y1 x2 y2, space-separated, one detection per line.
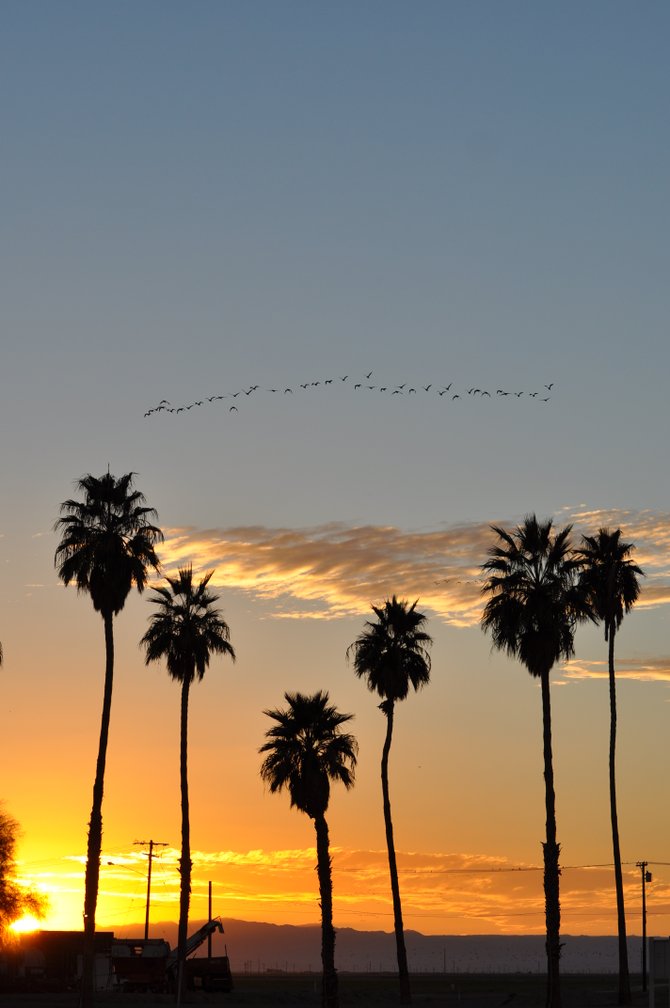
5 974 652 1008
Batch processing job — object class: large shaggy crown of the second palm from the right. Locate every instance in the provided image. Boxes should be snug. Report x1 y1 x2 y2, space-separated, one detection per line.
482 515 589 675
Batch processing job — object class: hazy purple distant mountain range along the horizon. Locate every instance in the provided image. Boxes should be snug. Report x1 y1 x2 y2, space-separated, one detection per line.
114 918 642 974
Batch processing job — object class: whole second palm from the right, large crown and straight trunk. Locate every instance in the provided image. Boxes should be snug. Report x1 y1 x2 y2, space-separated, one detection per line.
482 515 588 1008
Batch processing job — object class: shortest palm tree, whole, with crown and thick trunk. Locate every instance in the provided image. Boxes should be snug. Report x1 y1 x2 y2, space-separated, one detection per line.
259 690 358 1008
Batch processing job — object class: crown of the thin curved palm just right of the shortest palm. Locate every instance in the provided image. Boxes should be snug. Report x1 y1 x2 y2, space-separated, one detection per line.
347 595 432 703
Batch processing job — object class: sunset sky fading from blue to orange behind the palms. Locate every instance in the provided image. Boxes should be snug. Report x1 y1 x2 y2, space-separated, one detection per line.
0 0 670 934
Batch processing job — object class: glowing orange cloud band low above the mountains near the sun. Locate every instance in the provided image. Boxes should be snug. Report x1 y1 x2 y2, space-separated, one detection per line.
49 847 656 934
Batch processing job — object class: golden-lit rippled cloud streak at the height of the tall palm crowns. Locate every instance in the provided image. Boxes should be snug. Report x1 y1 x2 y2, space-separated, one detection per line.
157 509 670 627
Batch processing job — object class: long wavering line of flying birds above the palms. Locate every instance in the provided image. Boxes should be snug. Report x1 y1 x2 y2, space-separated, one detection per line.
144 371 554 417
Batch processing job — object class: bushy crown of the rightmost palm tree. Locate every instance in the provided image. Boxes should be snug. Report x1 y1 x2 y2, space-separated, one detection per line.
577 528 644 640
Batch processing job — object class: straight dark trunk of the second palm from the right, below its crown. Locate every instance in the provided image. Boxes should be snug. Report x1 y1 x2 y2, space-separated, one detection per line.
540 669 561 1008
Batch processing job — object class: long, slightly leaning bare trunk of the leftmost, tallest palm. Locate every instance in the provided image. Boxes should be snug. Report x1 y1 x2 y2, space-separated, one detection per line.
80 612 114 1008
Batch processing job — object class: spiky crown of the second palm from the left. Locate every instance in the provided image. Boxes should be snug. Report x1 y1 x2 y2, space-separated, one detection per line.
141 566 235 682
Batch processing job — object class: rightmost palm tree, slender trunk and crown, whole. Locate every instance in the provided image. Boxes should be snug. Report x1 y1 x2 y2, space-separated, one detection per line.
577 528 644 1005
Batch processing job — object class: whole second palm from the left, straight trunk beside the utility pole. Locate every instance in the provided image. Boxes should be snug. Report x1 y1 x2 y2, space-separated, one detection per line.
140 566 235 992
